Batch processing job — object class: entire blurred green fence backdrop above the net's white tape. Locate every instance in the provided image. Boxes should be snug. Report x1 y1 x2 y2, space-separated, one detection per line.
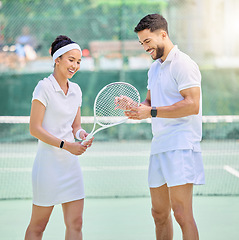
0 0 239 116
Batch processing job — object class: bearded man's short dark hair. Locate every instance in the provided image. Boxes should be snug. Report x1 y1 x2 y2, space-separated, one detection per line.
134 13 168 34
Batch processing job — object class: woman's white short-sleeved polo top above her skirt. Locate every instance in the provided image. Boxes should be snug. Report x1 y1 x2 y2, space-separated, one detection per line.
32 74 82 142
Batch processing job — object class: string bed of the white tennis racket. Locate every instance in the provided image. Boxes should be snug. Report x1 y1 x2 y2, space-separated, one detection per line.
95 83 140 125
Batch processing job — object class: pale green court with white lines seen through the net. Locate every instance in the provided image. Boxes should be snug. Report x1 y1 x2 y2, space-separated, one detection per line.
0 140 239 199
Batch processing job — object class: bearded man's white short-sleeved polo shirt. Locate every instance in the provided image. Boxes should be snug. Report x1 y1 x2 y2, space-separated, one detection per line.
147 46 202 154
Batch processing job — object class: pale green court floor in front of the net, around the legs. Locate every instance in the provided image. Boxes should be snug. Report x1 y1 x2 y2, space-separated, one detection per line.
0 196 239 240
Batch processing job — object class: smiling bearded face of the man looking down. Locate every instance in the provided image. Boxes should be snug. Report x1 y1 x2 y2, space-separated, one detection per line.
138 29 167 61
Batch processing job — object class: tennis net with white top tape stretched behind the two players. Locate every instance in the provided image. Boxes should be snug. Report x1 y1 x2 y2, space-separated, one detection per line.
0 116 239 199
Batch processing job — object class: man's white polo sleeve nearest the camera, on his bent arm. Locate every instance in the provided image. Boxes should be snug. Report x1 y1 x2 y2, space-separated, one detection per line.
172 57 201 91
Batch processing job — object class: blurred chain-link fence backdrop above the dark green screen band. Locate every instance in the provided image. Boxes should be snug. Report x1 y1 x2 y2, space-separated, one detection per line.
0 0 239 72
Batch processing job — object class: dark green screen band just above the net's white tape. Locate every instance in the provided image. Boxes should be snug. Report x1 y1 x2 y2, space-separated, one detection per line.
0 69 239 116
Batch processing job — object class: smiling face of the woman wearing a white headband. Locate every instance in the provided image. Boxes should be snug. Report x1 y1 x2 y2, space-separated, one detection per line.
55 49 81 78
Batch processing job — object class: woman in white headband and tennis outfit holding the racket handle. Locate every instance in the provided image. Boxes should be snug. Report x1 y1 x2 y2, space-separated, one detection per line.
25 36 93 240
